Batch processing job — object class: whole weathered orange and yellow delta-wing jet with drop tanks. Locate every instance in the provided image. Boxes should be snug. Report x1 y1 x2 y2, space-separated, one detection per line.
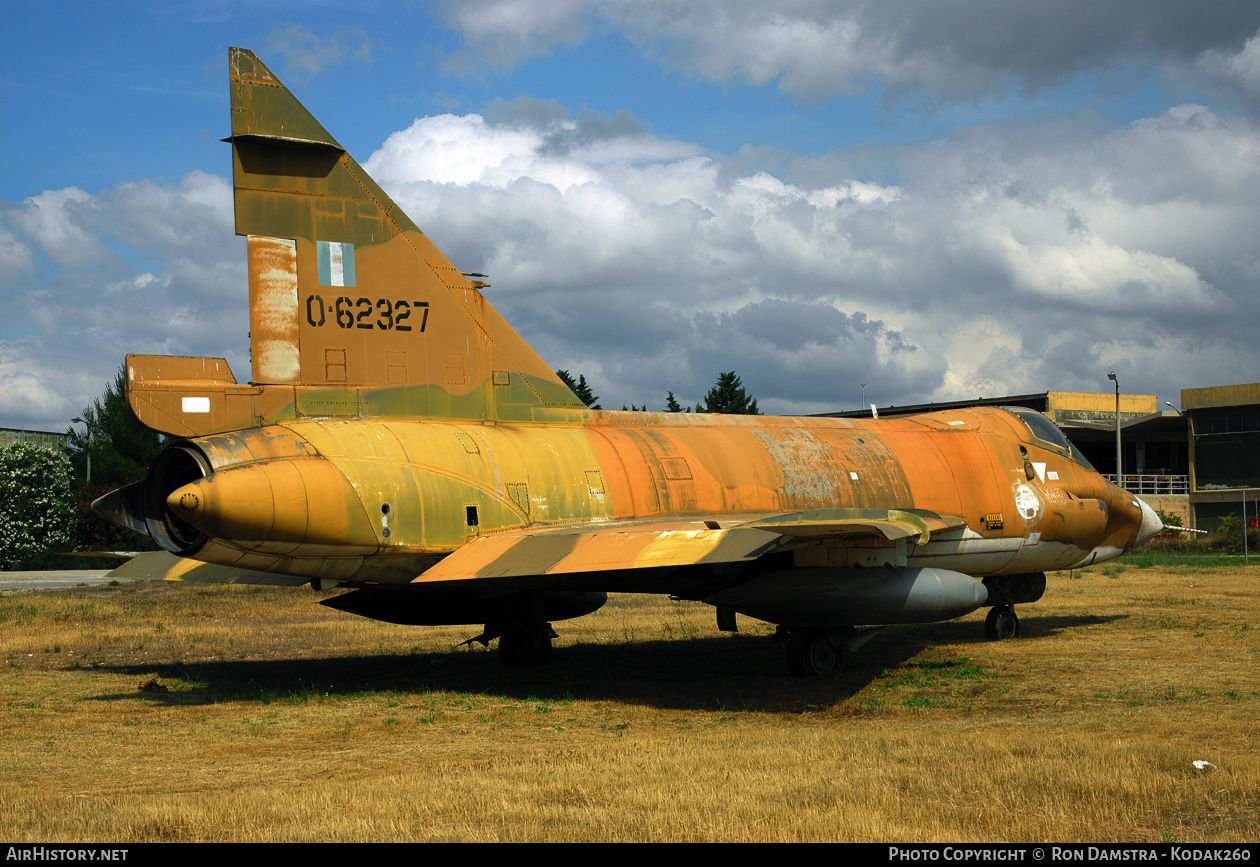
95 48 1160 673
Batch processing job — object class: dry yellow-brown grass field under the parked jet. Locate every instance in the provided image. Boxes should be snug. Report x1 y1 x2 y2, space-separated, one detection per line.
0 554 1260 842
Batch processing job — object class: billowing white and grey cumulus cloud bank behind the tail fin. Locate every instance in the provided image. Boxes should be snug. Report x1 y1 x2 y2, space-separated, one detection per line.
0 103 1260 426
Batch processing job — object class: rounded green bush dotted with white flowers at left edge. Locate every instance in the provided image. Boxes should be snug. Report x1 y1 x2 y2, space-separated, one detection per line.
0 442 74 568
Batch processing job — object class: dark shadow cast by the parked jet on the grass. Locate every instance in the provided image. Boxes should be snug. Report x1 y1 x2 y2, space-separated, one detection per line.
83 615 1126 716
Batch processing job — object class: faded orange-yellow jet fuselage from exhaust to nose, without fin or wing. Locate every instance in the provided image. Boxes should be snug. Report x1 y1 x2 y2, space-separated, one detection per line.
143 408 1143 592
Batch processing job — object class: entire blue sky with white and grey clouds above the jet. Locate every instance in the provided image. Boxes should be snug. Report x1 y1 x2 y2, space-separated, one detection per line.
0 0 1260 431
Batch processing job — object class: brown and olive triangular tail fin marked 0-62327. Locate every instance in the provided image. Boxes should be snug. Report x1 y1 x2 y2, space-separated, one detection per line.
129 48 582 436
